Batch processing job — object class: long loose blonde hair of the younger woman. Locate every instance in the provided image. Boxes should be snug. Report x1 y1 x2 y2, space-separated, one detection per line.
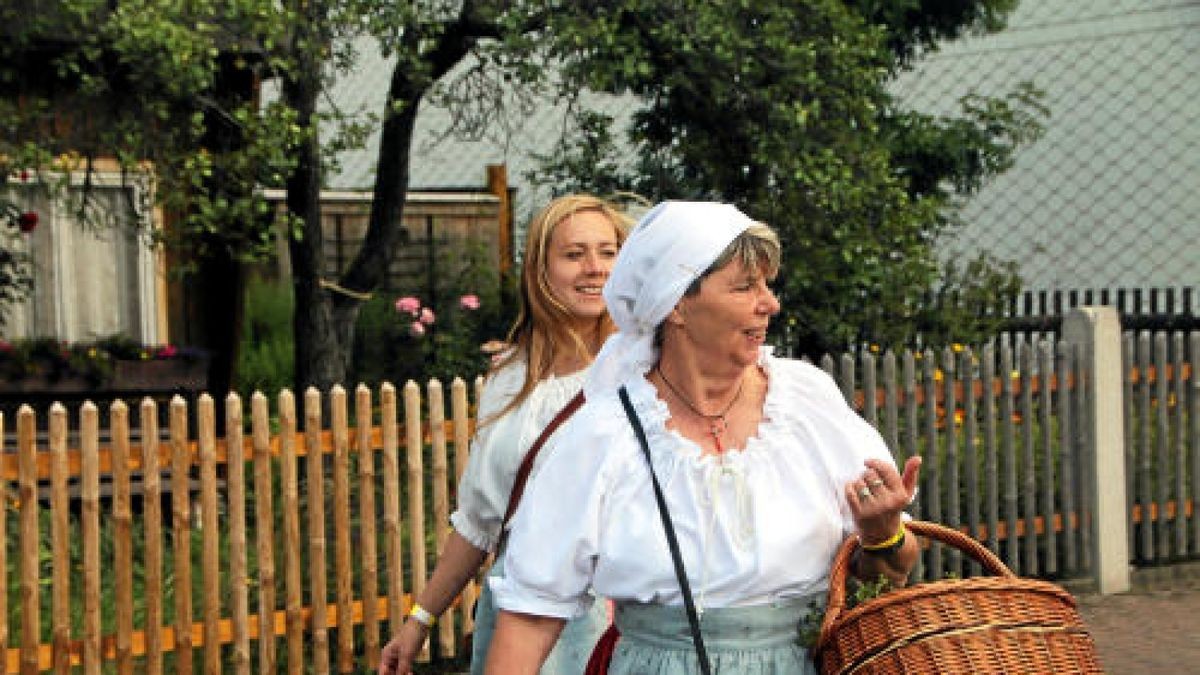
484 195 632 424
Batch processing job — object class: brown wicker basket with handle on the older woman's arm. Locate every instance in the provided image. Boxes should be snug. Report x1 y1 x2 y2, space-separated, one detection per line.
815 521 1103 675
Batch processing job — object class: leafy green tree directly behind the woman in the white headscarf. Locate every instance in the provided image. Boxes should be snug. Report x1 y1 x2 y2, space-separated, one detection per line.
532 0 1043 356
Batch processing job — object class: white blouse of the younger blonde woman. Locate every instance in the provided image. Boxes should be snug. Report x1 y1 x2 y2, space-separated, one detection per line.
450 360 587 551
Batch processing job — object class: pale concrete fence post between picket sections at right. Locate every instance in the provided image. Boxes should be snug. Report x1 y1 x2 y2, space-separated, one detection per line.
1062 306 1130 595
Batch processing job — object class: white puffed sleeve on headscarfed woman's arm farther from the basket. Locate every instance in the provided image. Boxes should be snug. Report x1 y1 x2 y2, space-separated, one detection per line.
488 400 614 619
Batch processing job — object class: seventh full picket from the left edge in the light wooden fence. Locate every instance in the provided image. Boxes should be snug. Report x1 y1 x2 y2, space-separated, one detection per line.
196 394 221 675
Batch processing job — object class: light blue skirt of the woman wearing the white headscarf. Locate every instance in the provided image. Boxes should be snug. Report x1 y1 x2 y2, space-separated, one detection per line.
608 595 823 675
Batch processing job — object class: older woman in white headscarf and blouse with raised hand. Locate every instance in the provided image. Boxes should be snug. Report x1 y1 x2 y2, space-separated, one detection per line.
487 202 920 674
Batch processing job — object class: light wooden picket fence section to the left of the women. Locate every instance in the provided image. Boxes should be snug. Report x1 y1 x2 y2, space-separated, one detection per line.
0 378 480 675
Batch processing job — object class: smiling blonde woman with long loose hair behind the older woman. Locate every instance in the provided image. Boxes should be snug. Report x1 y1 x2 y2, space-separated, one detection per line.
379 195 630 675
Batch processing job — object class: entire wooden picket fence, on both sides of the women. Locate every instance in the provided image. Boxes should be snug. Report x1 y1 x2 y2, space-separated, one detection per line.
0 324 1200 674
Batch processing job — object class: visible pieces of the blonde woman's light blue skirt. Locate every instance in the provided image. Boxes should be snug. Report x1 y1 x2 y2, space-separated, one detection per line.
470 555 608 675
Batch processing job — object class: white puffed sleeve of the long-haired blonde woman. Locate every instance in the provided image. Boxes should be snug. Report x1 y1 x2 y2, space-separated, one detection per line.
450 364 524 551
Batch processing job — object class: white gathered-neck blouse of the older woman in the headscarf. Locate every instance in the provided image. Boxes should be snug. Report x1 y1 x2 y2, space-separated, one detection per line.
491 350 893 619
